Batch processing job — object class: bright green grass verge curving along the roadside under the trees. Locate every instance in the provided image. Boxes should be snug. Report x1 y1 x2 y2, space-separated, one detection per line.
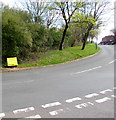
18 44 100 68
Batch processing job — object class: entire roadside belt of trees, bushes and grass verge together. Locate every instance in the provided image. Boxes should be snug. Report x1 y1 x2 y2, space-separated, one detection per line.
2 0 108 67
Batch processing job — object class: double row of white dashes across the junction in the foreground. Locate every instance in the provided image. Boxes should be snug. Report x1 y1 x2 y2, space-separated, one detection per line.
0 87 113 119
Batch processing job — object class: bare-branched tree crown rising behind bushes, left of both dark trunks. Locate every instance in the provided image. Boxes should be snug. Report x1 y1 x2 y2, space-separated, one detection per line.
21 0 59 28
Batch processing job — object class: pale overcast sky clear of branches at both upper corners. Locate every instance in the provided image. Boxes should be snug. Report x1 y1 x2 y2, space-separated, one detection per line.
0 0 116 42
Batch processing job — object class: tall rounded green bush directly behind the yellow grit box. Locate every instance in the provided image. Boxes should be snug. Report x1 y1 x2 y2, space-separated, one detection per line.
2 6 32 61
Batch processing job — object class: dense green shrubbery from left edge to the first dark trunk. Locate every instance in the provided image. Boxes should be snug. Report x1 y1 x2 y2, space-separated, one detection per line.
2 6 71 64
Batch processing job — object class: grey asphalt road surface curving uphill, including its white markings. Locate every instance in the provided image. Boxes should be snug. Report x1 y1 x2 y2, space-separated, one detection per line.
0 45 116 118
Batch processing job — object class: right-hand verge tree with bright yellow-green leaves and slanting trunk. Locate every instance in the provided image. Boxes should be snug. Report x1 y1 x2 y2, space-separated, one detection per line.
74 1 109 50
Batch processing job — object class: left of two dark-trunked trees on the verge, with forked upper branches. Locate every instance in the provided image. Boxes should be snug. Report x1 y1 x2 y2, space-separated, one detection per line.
55 1 81 50
